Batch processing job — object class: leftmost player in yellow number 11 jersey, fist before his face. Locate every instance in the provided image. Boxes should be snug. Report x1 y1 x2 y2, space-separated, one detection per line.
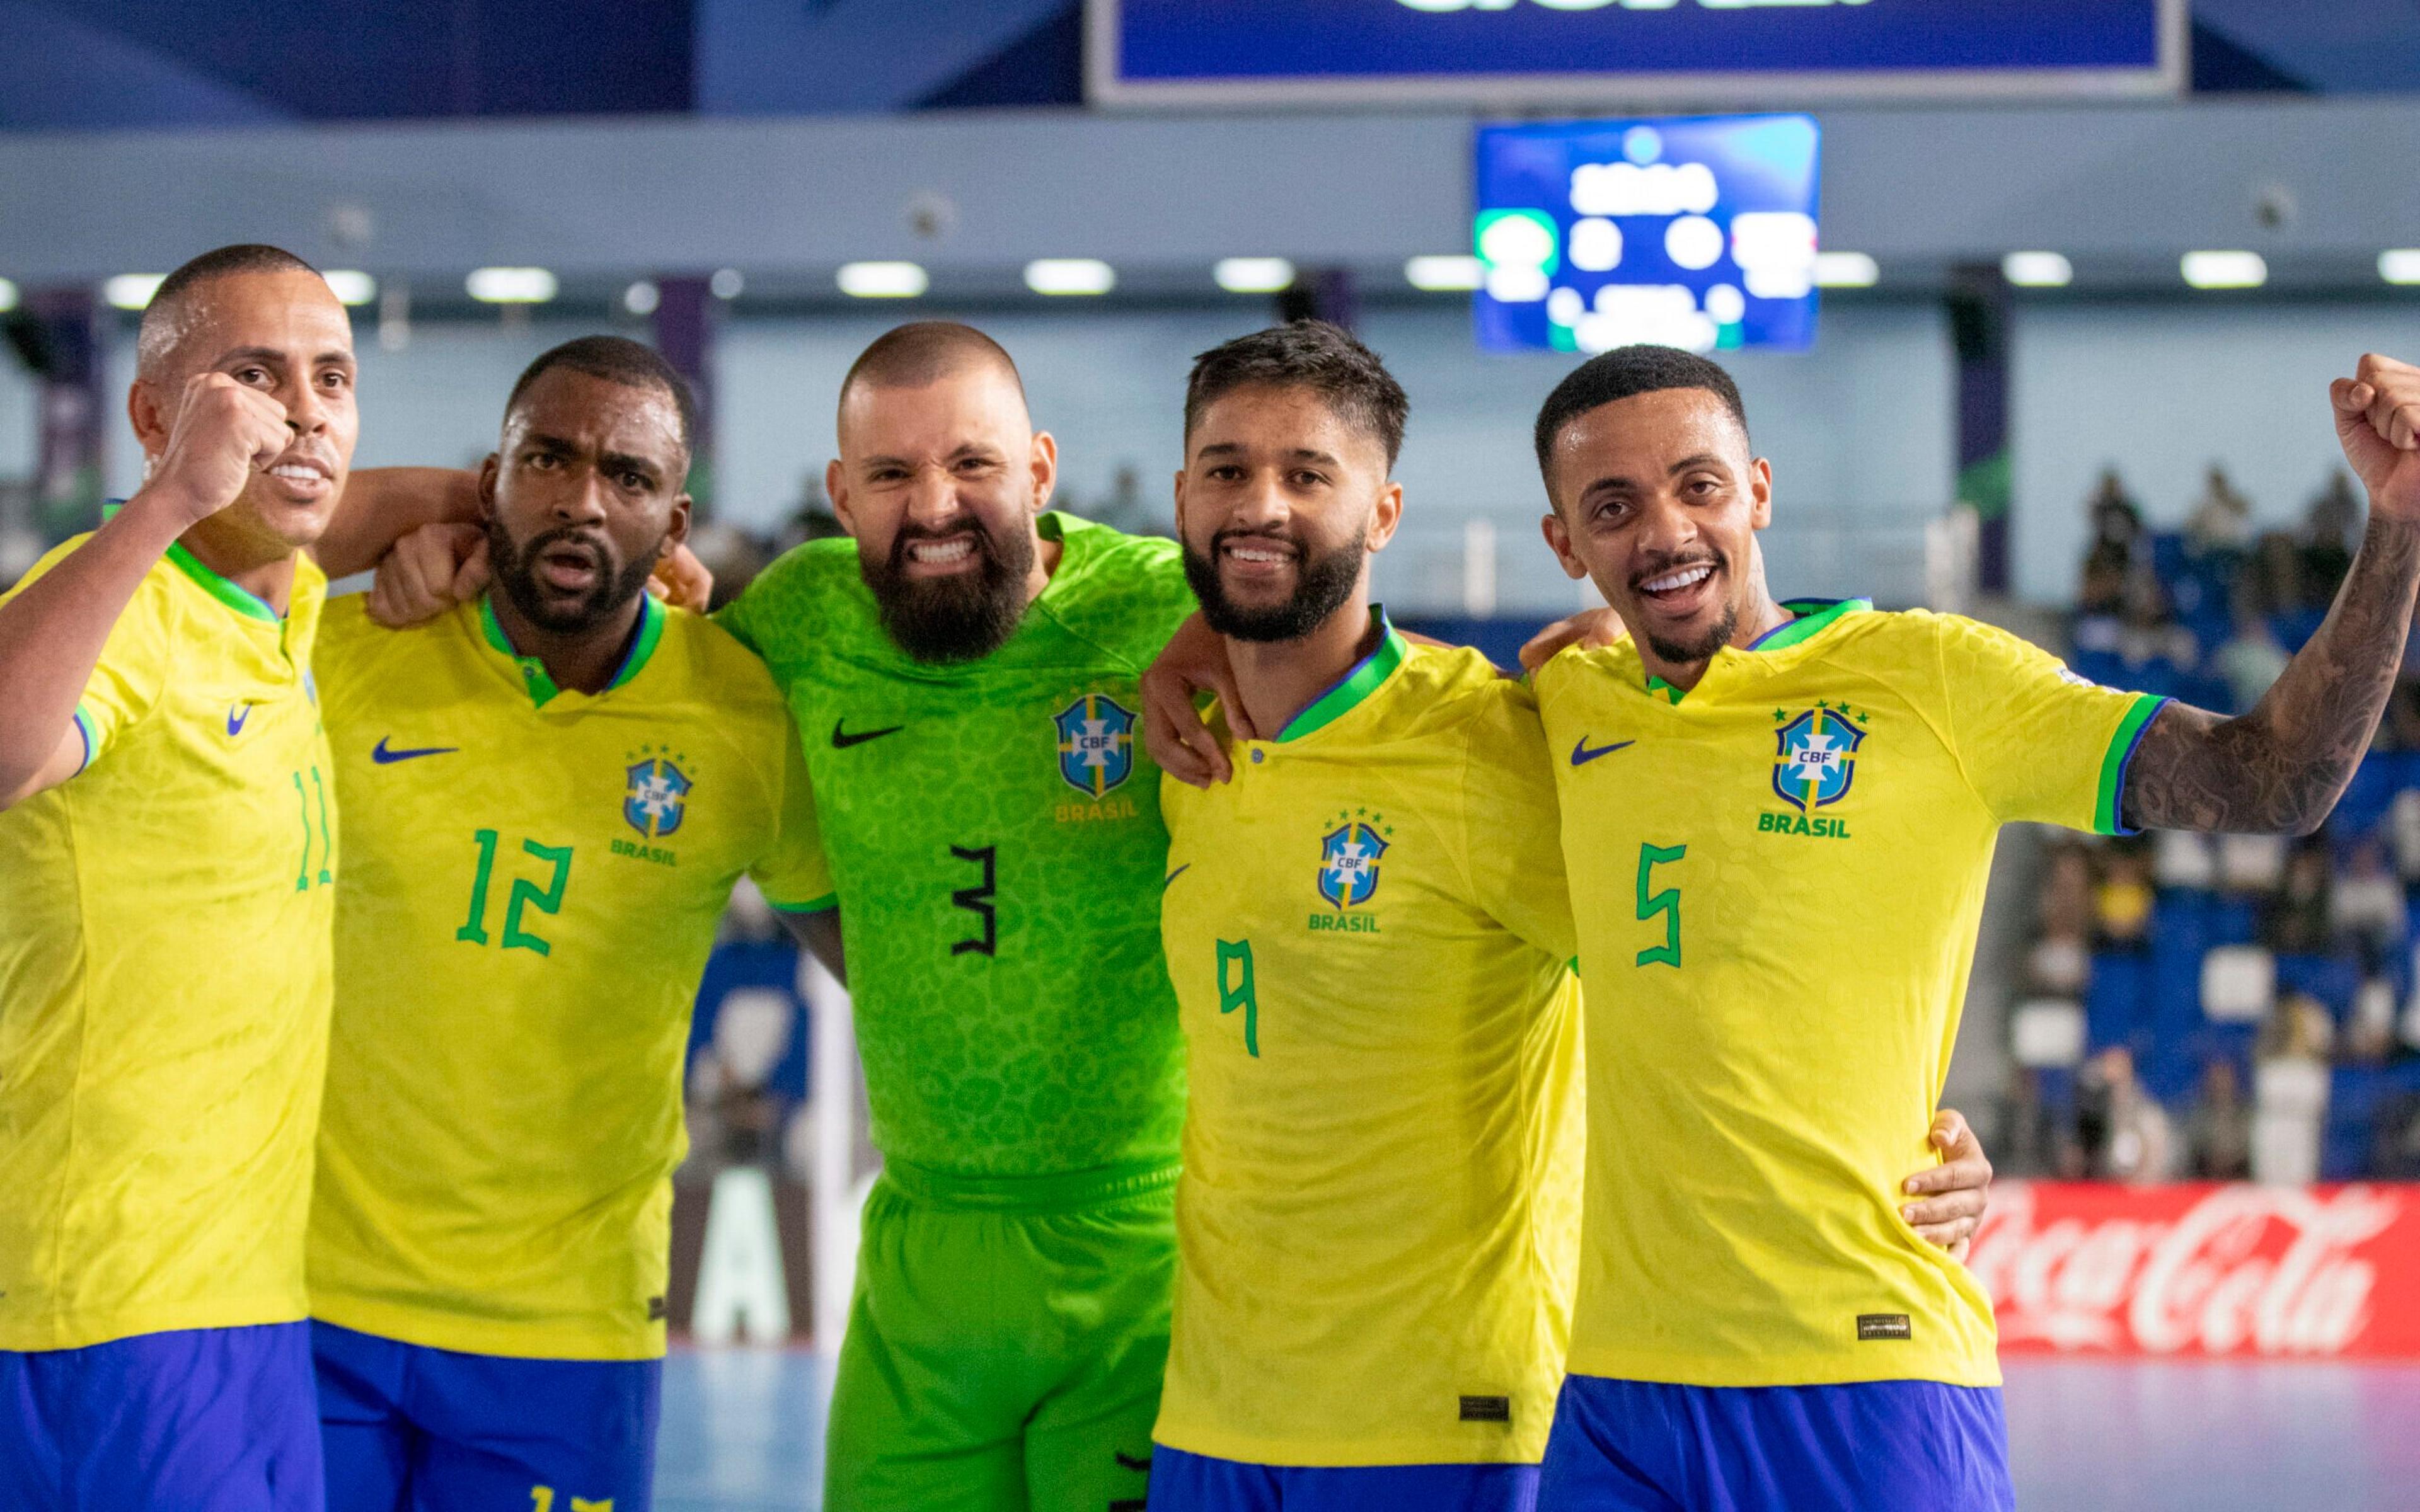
0 247 372 1512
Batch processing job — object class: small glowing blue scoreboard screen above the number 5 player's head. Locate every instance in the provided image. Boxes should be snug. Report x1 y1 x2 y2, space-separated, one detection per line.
1472 116 1820 353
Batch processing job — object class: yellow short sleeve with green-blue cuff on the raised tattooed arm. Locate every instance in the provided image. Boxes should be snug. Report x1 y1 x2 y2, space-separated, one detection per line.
1939 614 2169 835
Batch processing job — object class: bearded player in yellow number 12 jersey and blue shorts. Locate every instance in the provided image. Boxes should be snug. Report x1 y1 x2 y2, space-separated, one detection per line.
310 336 833 1512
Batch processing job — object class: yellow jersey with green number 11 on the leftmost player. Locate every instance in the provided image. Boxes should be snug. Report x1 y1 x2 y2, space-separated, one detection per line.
0 537 337 1350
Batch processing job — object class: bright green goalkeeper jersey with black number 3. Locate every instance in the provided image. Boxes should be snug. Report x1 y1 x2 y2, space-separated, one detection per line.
718 513 1193 1176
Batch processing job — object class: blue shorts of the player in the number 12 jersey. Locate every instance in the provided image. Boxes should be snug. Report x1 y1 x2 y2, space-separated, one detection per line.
310 1323 663 1512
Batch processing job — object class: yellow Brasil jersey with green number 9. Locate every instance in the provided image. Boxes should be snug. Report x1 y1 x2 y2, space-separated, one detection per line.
1155 631 1582 1466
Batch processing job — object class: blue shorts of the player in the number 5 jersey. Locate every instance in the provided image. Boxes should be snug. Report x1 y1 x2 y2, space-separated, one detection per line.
1539 1377 2016 1512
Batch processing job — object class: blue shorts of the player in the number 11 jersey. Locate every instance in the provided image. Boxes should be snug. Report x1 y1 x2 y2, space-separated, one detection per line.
0 1323 326 1512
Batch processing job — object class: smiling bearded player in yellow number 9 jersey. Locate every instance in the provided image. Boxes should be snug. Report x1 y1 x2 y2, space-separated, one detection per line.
1150 322 1581 1512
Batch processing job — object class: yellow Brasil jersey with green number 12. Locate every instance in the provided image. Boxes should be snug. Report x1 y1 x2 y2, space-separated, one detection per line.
310 590 833 1360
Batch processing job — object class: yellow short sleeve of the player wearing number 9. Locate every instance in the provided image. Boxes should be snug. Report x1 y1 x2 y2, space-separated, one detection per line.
1461 680 1581 960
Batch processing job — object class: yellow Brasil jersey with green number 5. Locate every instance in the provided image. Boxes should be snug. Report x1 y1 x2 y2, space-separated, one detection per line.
1536 600 2158 1386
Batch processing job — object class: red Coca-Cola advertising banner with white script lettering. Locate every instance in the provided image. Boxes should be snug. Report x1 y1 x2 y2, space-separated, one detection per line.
1968 1181 2420 1360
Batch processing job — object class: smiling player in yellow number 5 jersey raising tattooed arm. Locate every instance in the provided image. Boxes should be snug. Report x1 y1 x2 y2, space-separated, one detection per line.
1536 346 2420 1512
